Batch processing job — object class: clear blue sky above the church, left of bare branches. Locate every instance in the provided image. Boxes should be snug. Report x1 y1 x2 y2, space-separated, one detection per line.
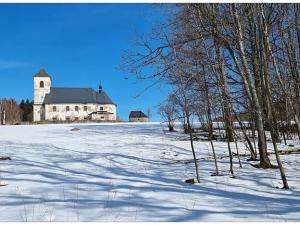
0 4 170 121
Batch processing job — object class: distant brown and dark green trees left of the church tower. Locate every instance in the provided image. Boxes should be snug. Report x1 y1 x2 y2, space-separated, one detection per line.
0 98 33 125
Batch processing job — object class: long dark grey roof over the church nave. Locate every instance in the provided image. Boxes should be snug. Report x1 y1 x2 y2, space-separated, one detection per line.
44 88 115 105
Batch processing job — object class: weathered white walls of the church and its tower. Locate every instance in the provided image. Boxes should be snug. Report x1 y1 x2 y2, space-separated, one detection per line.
33 70 117 122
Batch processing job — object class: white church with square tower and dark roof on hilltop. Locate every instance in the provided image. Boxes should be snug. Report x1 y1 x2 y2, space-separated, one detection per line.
33 69 117 122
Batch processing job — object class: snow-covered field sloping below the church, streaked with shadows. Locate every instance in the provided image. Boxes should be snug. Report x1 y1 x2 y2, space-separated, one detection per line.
0 123 300 222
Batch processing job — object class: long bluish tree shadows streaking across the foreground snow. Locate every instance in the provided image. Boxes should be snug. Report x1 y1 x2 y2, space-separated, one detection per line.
0 139 300 221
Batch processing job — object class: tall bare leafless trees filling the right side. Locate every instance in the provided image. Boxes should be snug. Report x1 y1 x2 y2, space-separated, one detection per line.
123 3 300 188
